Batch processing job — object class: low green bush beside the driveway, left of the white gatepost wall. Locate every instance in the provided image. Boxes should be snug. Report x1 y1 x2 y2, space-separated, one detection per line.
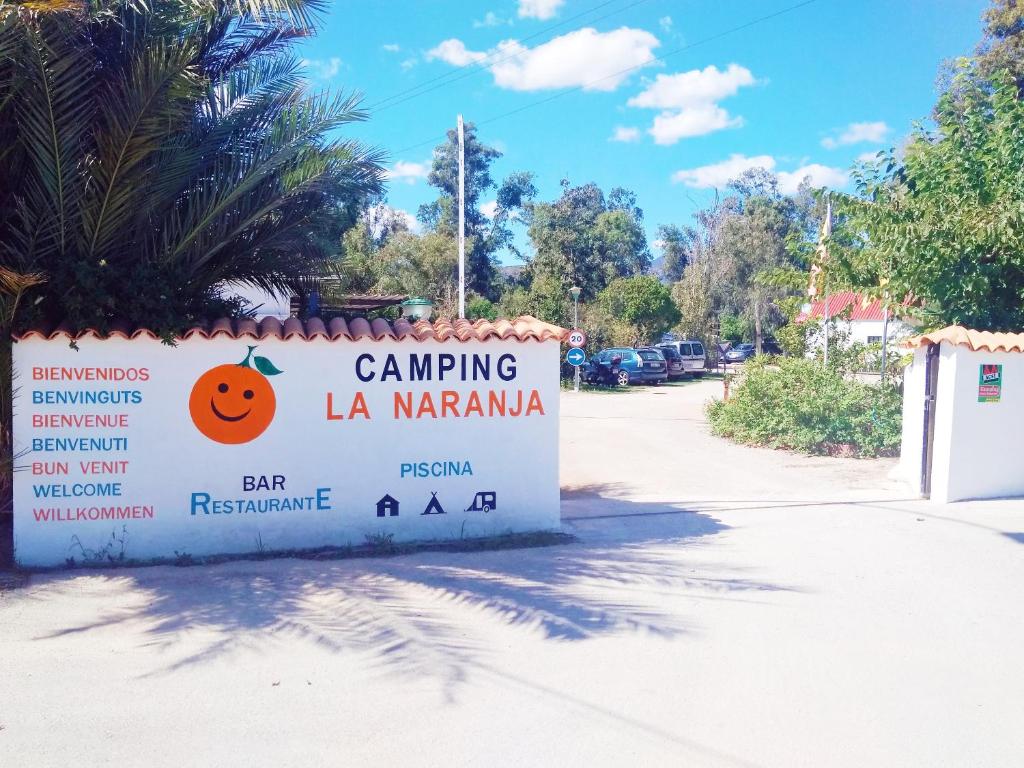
708 358 902 457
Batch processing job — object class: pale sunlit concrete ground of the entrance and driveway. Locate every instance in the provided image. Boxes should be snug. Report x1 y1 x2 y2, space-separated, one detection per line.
0 382 1024 768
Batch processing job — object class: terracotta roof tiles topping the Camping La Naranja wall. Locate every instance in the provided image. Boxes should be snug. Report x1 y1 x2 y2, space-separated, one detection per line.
14 315 568 341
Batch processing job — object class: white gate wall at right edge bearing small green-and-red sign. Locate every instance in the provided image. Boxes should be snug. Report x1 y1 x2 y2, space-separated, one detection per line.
899 342 1024 503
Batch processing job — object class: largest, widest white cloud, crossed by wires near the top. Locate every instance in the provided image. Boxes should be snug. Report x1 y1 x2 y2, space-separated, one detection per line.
427 27 660 91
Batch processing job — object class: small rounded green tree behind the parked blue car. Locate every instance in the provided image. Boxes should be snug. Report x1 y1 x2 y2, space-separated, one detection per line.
590 274 681 346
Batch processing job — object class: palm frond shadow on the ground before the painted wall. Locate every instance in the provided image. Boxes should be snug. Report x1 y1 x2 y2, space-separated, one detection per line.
27 486 785 695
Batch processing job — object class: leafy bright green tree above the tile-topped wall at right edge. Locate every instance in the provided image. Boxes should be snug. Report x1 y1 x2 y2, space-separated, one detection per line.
830 68 1024 330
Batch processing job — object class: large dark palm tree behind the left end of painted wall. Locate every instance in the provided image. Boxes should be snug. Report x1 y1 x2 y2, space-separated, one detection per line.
0 0 382 333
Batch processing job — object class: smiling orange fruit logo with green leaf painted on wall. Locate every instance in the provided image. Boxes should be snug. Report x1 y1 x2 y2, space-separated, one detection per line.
188 346 282 445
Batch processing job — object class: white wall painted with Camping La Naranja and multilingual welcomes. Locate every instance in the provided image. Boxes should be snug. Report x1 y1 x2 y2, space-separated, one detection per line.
14 337 559 565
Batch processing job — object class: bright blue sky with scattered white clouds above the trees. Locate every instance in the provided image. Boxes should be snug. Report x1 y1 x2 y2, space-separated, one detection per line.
301 0 986 264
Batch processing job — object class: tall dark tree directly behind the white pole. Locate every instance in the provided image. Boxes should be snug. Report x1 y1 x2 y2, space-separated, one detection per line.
417 123 537 299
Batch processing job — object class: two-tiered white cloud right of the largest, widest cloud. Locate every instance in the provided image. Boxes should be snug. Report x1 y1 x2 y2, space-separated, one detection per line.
627 63 757 144
